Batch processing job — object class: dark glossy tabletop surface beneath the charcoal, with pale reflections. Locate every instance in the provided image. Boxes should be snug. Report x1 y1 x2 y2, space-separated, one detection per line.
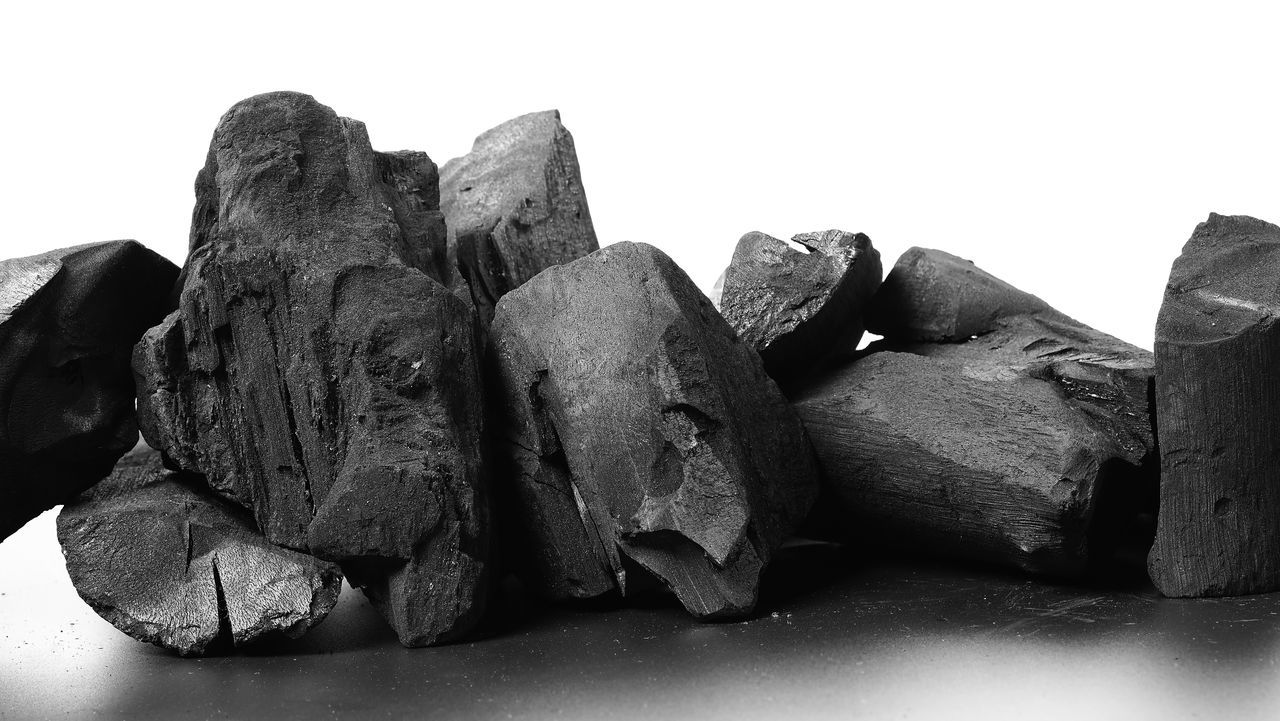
0 514 1280 718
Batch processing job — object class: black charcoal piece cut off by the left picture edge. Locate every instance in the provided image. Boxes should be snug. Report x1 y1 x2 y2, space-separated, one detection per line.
0 241 178 539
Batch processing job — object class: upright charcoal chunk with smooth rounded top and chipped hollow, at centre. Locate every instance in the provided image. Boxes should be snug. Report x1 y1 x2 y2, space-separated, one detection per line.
490 243 818 617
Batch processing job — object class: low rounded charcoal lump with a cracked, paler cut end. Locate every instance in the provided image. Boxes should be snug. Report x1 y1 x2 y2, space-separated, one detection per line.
58 448 342 656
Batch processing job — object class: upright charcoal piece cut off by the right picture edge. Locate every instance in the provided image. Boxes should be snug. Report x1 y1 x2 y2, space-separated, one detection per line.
1148 214 1280 597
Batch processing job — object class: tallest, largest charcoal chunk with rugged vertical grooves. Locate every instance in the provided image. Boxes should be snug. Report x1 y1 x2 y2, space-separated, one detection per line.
134 92 489 645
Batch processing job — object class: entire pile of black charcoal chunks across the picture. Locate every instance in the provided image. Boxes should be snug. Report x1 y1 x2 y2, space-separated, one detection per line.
0 92 1280 654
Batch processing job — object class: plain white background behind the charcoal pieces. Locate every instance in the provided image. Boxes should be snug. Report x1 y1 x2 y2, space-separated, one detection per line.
0 0 1280 717
